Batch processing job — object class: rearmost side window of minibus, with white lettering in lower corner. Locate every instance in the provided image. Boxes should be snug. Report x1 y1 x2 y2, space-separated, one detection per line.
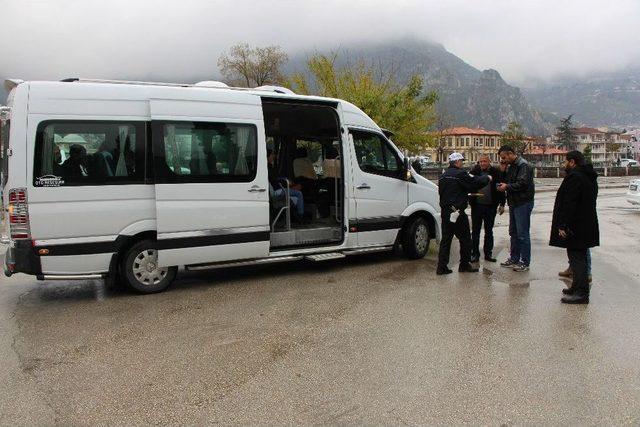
33 120 146 187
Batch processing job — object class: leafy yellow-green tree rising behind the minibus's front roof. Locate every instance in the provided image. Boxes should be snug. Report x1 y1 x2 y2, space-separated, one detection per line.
289 53 437 153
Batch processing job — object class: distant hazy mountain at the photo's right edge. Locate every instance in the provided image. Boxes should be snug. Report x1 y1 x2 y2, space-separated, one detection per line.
524 67 640 128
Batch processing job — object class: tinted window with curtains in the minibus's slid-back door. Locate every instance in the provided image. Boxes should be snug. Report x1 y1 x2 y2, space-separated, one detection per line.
152 122 258 183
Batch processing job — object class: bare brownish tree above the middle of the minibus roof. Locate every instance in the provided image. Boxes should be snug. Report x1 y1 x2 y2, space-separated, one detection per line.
218 43 288 87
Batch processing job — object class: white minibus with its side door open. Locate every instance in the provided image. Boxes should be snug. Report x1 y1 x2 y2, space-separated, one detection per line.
0 79 440 293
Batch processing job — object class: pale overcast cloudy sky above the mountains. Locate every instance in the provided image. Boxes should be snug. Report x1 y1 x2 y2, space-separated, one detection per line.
0 0 640 89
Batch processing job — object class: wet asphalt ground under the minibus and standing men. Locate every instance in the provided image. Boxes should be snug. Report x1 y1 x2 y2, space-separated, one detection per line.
0 189 640 425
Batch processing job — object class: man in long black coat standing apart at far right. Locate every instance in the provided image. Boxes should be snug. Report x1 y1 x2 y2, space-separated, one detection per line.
549 151 600 304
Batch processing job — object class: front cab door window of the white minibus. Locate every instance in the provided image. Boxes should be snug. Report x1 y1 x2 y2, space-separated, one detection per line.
351 130 402 179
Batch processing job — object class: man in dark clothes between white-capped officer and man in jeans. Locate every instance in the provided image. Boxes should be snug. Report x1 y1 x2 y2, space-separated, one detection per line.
469 154 505 262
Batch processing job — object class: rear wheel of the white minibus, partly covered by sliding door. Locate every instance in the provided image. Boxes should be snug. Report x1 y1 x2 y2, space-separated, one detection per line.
121 240 178 294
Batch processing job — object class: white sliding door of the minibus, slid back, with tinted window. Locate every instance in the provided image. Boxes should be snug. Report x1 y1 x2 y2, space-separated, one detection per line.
151 99 270 266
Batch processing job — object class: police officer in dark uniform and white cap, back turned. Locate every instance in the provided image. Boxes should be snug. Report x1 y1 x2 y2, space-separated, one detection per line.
436 153 492 274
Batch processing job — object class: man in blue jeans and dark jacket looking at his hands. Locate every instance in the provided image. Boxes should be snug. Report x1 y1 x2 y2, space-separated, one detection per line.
497 145 536 271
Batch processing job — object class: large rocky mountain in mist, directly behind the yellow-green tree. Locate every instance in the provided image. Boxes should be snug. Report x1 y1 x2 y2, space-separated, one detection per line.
286 39 553 135
